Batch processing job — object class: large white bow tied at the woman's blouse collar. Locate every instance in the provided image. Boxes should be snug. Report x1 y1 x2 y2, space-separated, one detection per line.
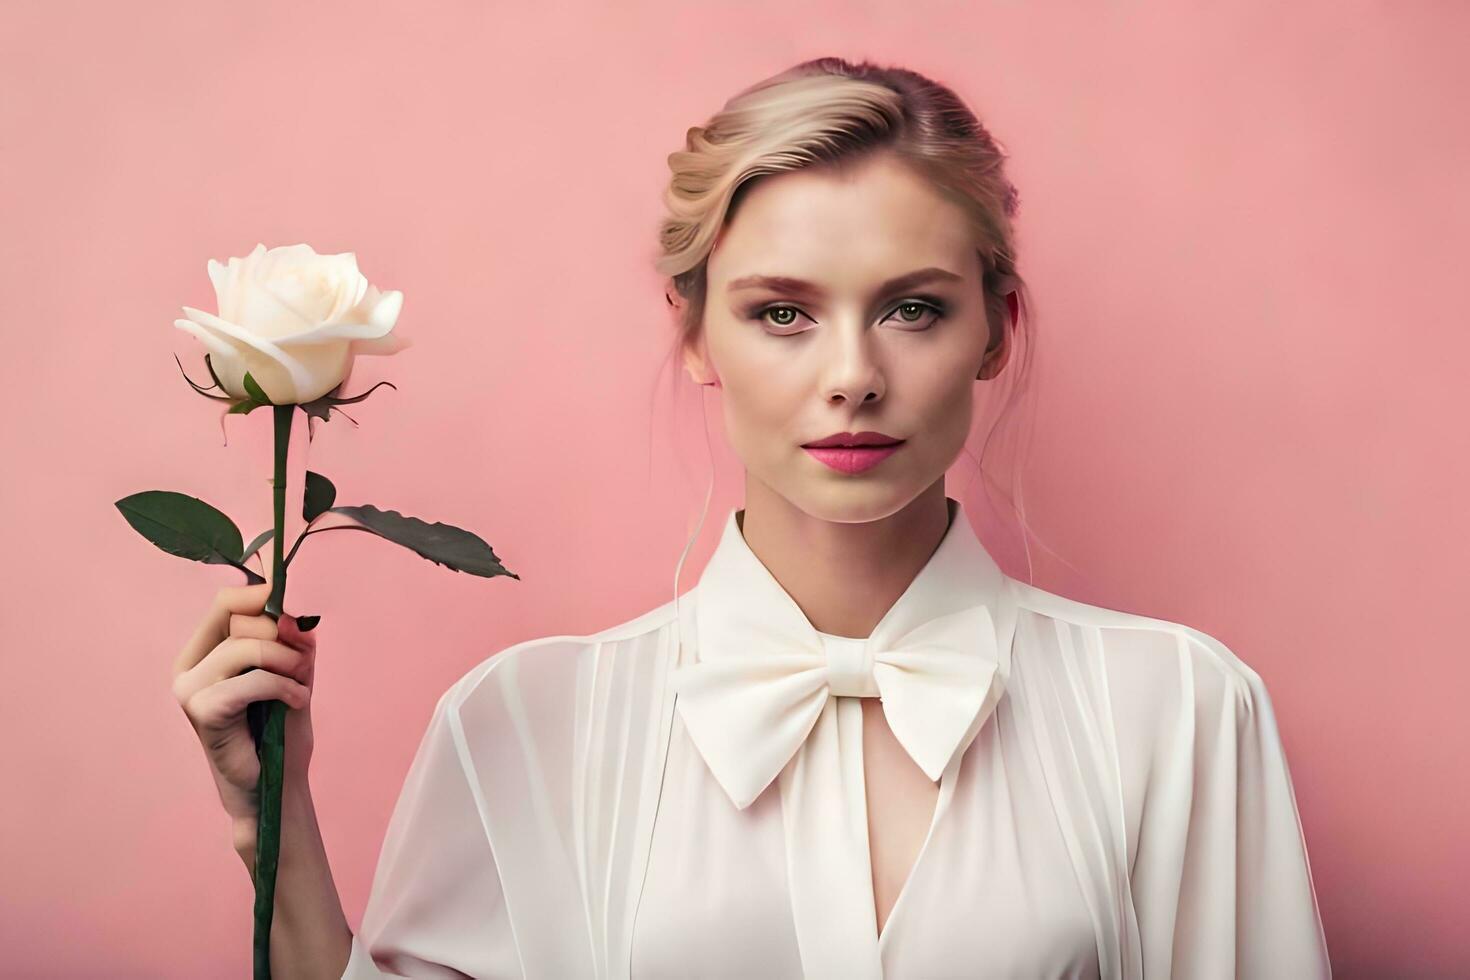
670 604 1004 810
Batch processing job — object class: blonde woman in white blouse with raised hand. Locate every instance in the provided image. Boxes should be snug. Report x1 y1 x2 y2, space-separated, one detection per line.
171 59 1329 979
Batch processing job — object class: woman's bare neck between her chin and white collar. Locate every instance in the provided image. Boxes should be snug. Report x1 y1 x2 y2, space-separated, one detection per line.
735 475 950 638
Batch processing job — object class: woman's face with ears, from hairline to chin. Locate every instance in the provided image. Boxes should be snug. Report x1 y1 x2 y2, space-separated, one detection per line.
685 149 1008 522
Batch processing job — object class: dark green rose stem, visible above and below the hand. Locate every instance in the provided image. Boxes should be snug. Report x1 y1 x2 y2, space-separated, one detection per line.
250 406 295 980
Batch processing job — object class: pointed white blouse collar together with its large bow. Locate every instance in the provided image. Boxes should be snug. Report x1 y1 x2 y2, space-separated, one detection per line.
675 497 1010 808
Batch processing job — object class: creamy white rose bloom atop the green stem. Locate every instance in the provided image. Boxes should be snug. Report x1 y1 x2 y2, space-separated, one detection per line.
173 244 409 406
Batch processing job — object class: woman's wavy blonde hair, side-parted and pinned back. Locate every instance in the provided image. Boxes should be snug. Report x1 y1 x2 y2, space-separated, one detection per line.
654 57 1058 581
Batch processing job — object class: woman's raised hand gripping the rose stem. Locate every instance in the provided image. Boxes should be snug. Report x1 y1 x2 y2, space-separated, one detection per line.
173 582 316 851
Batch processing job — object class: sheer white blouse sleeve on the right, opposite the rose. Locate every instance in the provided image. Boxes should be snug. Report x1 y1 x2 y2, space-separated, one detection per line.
1130 627 1332 980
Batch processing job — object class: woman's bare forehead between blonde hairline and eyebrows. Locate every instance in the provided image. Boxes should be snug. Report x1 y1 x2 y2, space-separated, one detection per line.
709 154 975 282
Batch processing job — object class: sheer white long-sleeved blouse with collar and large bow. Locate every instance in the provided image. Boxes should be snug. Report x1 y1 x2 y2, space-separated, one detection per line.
344 498 1330 980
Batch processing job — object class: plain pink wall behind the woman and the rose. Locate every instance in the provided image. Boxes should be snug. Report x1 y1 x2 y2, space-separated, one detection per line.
0 0 1470 977
